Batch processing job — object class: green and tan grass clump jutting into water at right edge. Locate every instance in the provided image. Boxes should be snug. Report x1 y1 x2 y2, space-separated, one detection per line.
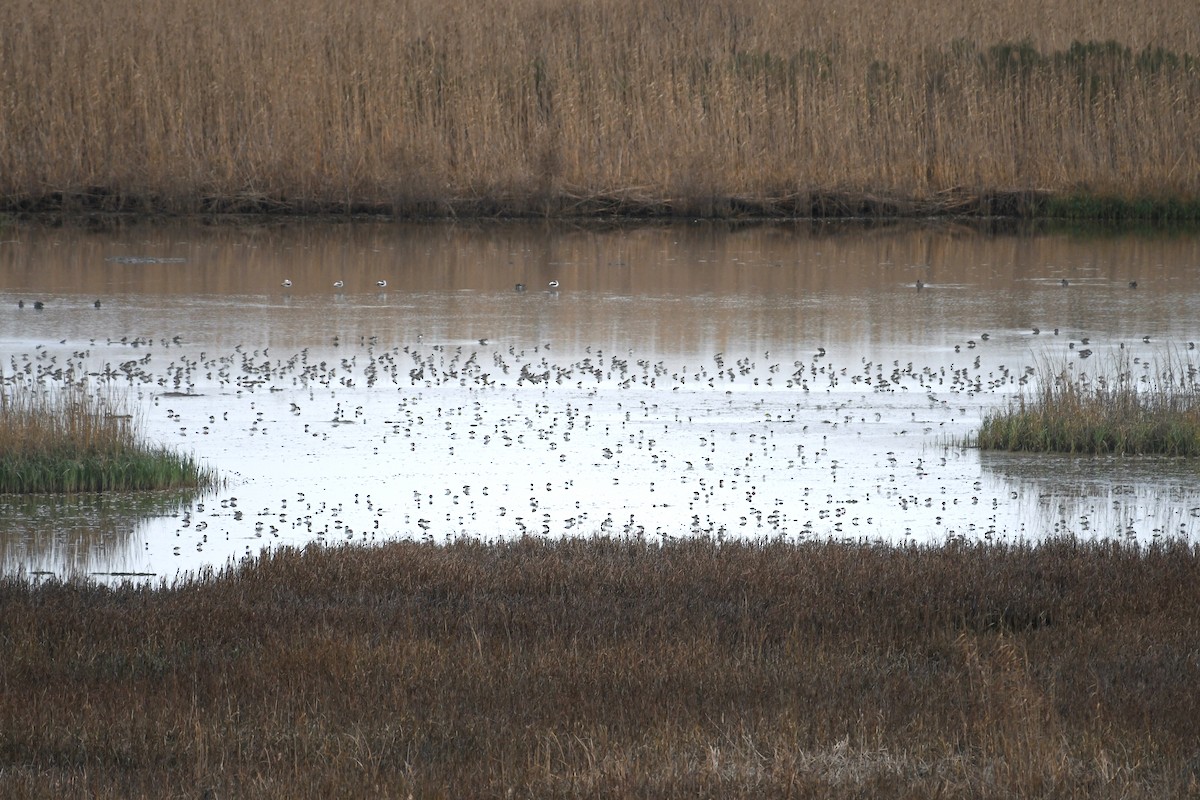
968 356 1200 456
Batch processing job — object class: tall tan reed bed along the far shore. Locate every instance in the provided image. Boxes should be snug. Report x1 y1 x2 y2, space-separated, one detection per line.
0 0 1200 219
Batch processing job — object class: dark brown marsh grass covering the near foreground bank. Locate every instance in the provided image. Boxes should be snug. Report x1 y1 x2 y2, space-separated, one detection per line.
0 539 1200 798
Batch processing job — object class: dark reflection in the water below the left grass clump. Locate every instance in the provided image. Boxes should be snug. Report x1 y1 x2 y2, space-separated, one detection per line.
0 489 199 576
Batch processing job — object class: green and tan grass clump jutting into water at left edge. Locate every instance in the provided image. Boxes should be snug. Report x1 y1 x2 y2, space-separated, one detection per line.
0 384 215 494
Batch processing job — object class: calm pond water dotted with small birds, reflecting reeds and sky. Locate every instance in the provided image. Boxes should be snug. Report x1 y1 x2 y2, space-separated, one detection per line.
0 223 1200 579
